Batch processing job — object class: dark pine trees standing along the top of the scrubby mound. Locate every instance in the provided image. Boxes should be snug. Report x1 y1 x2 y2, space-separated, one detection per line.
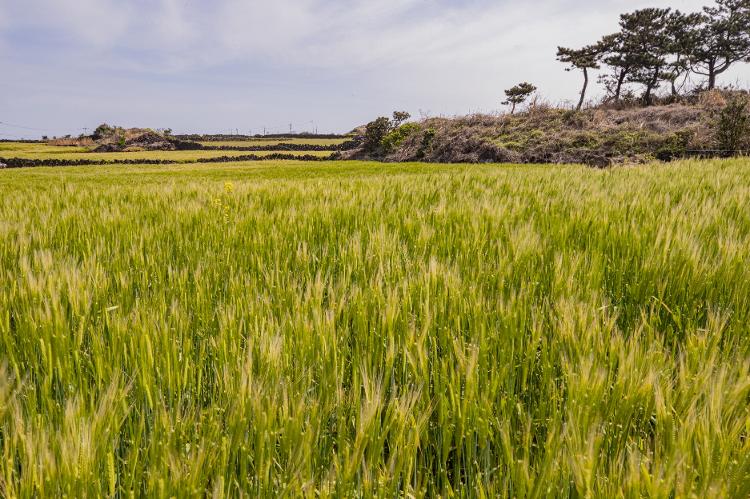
540 0 750 109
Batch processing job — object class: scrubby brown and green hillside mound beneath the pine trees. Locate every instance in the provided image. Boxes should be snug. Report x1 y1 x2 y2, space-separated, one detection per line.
341 91 750 166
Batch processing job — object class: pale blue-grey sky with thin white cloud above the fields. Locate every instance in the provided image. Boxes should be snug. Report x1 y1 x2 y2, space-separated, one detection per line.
0 0 750 139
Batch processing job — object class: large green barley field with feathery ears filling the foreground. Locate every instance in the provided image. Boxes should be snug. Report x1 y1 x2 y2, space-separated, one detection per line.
0 160 750 498
